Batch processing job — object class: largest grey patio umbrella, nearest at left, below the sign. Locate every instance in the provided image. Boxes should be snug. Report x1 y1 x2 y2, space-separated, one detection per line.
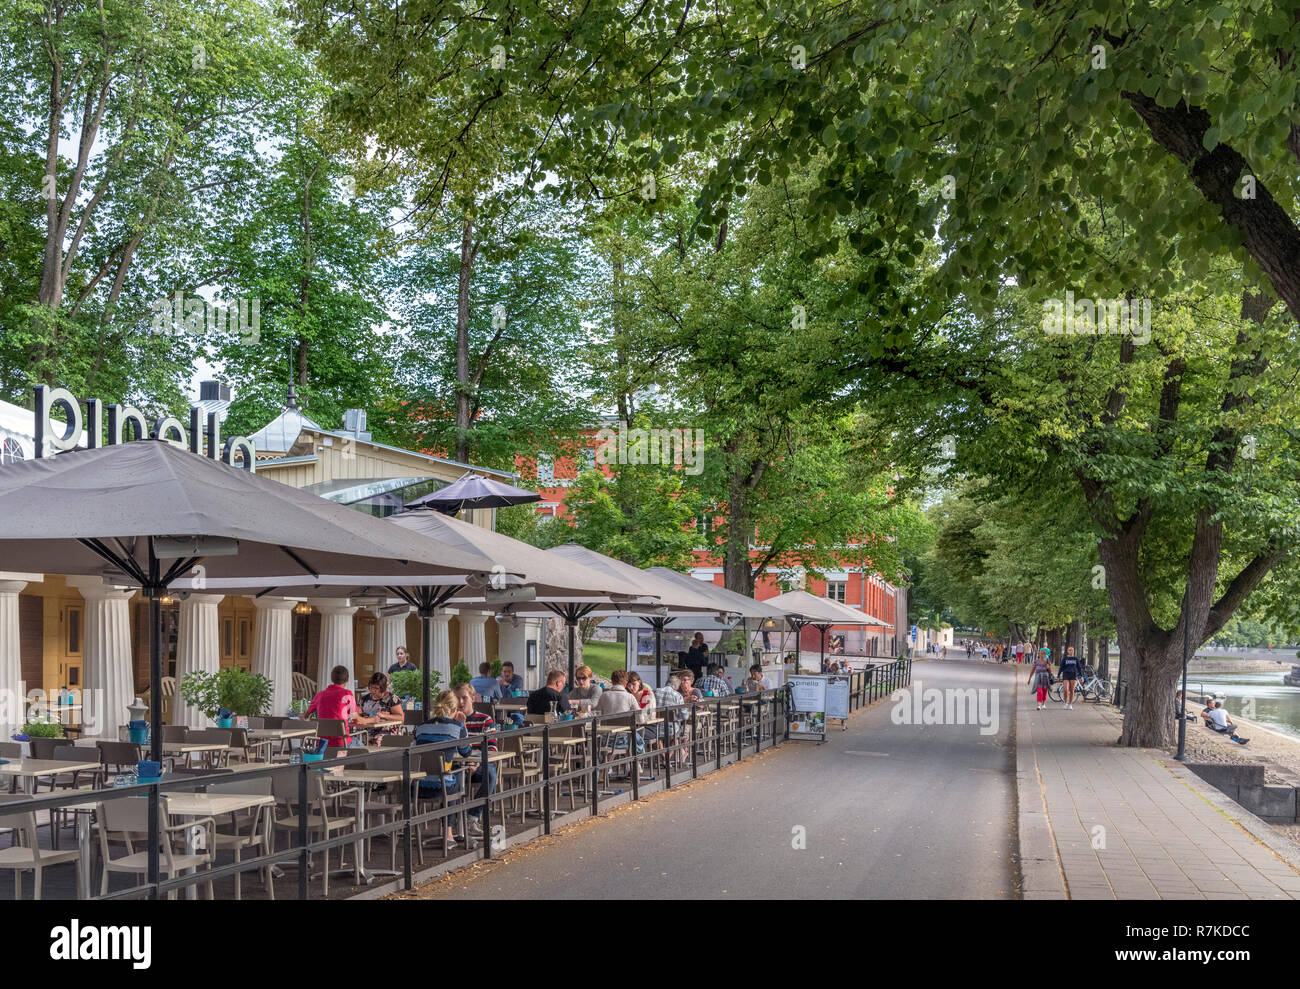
0 439 512 882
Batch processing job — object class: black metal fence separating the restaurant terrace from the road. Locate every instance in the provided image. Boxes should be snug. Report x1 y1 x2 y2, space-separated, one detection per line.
0 658 911 899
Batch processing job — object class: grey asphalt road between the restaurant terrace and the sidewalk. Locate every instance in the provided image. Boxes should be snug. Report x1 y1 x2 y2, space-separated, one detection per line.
400 660 1023 899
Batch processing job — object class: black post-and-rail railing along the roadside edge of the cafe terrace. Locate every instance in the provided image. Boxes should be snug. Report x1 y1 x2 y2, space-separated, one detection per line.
0 656 911 899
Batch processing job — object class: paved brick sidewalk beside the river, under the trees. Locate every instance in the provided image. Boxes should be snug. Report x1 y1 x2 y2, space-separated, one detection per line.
1015 667 1300 899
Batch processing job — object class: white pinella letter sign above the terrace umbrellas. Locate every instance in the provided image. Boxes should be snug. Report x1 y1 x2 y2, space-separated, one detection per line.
34 385 257 473
